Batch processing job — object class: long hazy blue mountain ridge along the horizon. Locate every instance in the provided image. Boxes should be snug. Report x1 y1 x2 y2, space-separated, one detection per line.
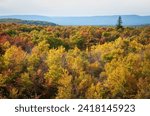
0 15 150 26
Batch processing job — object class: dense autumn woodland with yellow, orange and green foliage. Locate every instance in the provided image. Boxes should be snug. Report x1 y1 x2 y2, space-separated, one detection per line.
0 23 150 99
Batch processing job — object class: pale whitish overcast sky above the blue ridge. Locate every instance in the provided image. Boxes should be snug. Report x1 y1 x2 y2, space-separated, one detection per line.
0 0 150 16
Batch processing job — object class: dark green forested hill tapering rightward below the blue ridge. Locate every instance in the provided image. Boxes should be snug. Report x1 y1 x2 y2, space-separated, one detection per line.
0 18 56 26
